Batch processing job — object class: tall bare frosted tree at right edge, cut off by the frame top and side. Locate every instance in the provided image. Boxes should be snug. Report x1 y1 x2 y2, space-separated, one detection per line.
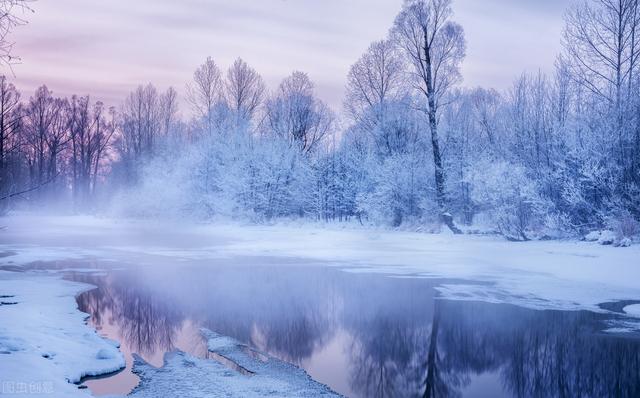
563 0 640 194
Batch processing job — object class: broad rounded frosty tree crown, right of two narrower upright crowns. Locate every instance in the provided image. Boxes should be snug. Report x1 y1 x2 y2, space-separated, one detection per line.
266 72 335 154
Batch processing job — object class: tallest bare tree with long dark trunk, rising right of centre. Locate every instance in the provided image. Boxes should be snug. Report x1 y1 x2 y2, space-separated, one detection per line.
392 0 466 232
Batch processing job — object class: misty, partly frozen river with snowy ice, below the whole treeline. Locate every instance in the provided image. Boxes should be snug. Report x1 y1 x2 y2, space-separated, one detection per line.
0 214 640 398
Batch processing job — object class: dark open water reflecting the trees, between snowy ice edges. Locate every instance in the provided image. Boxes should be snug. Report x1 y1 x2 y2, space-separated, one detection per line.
69 266 640 398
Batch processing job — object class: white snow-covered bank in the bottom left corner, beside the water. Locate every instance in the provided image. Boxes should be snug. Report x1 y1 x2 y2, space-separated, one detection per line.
0 271 125 397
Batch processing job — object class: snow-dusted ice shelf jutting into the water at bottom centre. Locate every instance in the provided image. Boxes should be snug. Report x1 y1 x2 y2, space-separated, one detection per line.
129 330 340 398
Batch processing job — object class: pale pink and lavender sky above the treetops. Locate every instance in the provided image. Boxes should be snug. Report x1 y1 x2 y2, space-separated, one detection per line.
5 0 570 113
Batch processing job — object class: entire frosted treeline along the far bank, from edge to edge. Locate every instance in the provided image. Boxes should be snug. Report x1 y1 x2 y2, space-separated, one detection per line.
0 0 640 241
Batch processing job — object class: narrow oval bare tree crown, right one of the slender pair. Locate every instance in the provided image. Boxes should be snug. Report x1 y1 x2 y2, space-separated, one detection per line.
225 58 265 121
